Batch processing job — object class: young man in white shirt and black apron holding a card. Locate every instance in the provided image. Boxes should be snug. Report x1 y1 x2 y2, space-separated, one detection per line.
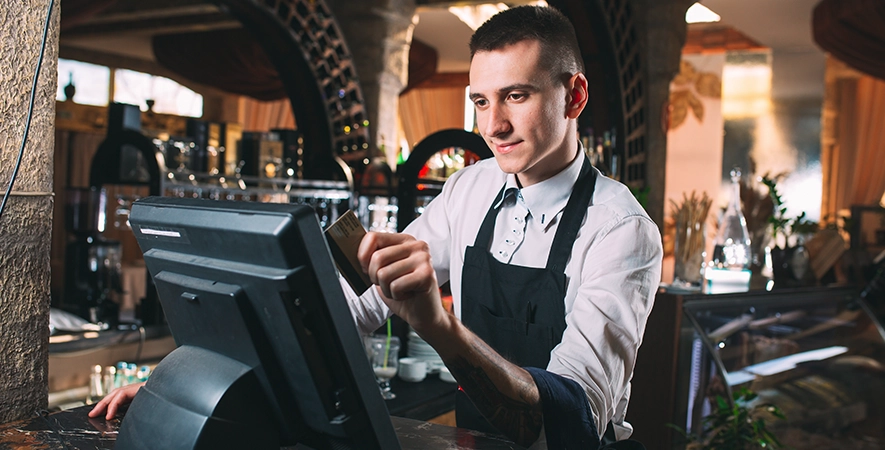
90 7 662 449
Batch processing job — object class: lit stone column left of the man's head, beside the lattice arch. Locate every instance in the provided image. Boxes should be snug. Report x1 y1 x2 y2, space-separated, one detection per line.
326 0 417 163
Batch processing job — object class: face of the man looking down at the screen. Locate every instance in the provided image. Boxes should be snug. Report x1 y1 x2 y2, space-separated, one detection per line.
470 40 583 187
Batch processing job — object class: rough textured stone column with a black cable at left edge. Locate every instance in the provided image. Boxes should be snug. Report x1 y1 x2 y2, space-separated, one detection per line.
0 0 59 423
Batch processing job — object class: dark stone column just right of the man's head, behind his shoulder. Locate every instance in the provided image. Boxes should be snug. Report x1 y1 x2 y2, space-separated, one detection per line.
631 0 694 230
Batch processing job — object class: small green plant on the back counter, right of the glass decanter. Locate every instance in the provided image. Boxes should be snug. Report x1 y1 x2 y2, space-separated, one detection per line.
762 175 818 287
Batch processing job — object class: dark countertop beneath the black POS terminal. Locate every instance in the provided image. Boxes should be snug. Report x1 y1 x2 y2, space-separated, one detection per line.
0 406 522 450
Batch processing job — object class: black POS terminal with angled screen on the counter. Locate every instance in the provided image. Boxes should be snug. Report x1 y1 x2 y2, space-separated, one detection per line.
116 197 400 450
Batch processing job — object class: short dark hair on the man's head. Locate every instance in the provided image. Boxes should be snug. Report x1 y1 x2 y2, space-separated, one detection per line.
470 5 584 76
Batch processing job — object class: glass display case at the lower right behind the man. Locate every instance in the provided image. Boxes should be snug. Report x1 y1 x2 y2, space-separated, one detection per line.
628 288 885 450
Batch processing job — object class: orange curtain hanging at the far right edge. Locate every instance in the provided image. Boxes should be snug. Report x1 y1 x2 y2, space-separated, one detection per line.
821 57 885 219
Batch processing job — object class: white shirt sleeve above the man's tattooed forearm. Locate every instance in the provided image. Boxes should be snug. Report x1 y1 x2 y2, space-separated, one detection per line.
547 213 663 439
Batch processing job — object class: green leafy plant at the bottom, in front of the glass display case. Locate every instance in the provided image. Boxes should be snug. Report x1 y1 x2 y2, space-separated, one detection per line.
668 388 785 450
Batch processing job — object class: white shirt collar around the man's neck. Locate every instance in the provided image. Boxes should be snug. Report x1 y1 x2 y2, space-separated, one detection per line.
486 143 584 229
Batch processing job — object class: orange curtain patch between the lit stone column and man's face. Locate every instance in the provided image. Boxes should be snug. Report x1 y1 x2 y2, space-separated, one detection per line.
399 85 467 147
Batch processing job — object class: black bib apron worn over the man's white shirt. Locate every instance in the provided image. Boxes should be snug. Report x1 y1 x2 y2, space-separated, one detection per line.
455 156 613 437
